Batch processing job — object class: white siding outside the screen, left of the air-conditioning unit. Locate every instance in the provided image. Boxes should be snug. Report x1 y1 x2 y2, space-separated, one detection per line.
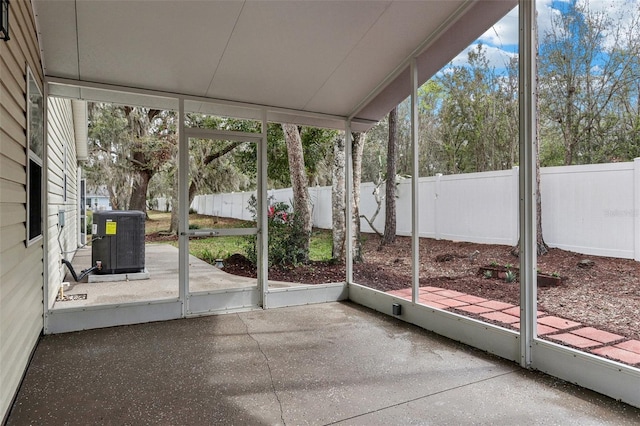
46 97 78 307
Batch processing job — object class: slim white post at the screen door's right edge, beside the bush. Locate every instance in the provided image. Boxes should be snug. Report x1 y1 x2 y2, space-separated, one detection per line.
256 108 269 309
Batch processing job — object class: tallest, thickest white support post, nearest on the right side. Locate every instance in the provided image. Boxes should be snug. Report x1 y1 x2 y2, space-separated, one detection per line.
518 0 537 368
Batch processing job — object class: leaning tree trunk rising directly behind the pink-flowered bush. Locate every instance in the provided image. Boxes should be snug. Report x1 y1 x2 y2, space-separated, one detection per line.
282 124 313 253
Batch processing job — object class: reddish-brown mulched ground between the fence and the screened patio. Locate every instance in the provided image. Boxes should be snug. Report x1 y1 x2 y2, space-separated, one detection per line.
219 236 640 339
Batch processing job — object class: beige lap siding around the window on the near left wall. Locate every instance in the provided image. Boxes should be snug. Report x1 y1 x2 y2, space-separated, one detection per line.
0 1 44 421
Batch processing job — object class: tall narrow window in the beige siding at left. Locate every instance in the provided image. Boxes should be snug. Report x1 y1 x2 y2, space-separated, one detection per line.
27 67 44 245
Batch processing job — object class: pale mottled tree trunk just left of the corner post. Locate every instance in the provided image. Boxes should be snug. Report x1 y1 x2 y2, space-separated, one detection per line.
331 137 346 261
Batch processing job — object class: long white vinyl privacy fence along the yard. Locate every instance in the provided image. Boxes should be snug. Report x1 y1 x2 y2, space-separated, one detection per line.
161 159 640 260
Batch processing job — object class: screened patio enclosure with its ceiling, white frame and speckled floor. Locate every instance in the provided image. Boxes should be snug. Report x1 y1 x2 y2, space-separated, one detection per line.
2 0 640 424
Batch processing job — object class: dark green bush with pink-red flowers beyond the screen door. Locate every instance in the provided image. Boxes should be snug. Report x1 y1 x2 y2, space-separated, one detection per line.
247 196 309 267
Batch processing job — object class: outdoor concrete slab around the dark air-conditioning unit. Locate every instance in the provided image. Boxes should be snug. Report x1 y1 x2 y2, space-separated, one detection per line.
52 244 300 309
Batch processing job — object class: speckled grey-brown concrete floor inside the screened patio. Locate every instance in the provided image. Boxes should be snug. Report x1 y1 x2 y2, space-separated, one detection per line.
8 303 640 425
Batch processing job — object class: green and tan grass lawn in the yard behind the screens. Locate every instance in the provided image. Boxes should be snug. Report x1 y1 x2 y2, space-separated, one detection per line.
145 211 332 263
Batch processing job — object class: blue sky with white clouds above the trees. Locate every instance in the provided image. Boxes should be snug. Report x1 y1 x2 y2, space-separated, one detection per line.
452 0 639 69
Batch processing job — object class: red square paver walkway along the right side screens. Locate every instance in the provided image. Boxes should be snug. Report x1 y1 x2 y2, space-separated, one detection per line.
388 286 640 367
